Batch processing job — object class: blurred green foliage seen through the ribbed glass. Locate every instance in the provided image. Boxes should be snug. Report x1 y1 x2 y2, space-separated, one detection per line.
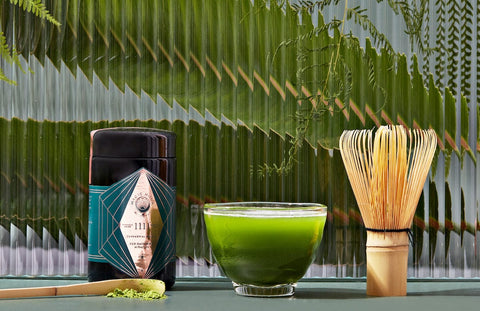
0 0 480 276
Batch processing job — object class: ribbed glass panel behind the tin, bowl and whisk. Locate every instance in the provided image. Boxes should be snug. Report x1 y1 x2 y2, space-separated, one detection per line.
0 0 480 278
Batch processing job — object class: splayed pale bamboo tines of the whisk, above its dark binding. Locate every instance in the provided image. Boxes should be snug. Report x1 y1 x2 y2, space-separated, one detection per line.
340 125 436 229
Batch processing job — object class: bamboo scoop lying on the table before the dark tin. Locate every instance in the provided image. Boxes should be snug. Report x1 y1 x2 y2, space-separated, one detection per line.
0 279 165 298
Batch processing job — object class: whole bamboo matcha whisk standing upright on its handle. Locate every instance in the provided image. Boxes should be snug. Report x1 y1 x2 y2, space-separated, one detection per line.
339 125 436 296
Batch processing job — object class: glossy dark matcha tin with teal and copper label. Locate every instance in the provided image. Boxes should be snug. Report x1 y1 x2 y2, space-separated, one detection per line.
88 128 176 289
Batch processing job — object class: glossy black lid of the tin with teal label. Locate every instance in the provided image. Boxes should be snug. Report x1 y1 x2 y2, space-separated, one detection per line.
90 127 176 158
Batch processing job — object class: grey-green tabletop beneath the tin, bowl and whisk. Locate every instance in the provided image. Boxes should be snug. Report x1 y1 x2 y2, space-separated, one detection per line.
0 278 480 311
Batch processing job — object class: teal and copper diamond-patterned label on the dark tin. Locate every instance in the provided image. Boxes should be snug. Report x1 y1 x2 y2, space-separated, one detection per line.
88 168 175 278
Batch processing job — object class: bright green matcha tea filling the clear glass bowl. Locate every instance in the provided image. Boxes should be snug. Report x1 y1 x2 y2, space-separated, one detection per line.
205 208 326 286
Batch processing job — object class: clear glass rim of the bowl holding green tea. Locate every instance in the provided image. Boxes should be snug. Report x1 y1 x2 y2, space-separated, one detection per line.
204 201 327 217
